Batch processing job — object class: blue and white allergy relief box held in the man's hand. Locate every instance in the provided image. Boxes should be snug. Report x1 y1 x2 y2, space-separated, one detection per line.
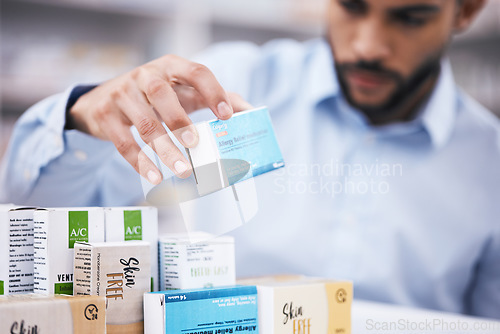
186 107 285 196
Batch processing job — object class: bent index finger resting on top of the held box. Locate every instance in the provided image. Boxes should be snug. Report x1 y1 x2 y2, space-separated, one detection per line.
156 55 233 119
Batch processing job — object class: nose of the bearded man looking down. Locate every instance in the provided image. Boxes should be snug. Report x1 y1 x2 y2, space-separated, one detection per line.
353 19 391 62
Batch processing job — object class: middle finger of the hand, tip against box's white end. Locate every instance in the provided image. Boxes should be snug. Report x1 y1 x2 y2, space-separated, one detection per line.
138 73 198 147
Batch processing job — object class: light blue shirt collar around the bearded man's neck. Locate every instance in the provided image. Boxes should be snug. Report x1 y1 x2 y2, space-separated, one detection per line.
309 39 457 148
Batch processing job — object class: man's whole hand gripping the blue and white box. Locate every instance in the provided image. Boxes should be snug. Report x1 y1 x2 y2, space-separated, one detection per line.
69 55 251 184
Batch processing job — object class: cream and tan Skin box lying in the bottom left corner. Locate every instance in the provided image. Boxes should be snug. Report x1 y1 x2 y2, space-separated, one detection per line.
0 294 106 334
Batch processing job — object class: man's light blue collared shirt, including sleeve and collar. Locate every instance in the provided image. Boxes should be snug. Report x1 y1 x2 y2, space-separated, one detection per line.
0 40 500 319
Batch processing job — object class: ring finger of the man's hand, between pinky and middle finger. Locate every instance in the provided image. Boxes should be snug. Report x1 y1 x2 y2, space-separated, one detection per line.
114 89 191 178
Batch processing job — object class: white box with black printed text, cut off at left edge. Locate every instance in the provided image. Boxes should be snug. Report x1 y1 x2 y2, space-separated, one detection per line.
0 205 35 295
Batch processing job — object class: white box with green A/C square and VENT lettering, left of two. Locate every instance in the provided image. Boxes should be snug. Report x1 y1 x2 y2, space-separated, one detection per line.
34 208 104 295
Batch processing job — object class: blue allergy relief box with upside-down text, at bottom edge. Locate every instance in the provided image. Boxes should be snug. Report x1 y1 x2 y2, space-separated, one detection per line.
144 286 259 334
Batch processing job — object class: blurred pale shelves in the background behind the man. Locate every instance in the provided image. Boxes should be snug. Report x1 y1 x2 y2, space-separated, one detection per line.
0 0 500 158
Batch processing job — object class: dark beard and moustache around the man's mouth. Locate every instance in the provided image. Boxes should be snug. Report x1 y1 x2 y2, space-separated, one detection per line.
335 52 441 119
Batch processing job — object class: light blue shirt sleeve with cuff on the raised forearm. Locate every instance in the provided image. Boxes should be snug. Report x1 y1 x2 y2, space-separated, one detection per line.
0 87 141 206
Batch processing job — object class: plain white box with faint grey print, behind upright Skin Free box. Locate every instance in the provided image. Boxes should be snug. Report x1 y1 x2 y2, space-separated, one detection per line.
160 232 236 290
